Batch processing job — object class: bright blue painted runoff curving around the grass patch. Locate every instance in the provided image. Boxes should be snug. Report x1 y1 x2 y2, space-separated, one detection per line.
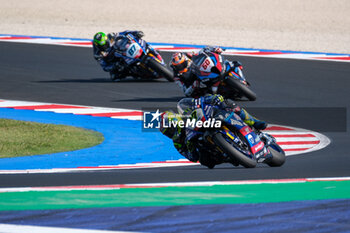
0 108 183 170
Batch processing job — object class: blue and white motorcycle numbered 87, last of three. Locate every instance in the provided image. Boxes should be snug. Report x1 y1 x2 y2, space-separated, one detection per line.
113 34 174 82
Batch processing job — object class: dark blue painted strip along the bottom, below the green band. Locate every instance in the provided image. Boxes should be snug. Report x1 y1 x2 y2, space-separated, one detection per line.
0 198 350 233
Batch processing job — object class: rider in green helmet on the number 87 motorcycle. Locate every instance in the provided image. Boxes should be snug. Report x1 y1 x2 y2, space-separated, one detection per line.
92 30 144 80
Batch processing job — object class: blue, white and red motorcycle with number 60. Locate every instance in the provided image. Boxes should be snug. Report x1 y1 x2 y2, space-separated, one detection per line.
192 49 256 101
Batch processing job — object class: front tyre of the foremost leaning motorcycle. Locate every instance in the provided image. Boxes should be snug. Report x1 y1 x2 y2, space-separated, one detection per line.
213 133 257 168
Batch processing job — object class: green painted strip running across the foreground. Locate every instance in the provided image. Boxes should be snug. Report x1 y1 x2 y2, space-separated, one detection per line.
0 181 350 211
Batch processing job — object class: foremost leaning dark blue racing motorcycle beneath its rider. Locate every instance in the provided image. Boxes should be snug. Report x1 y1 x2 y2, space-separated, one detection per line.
180 103 285 168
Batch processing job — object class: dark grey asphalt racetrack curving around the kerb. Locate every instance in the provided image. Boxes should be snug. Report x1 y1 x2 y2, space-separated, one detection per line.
0 42 350 187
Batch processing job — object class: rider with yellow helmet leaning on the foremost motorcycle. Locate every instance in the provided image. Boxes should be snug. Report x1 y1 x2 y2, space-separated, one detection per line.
160 95 267 168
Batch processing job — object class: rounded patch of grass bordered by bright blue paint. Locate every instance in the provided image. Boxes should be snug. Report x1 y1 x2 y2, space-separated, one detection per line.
0 119 104 158
